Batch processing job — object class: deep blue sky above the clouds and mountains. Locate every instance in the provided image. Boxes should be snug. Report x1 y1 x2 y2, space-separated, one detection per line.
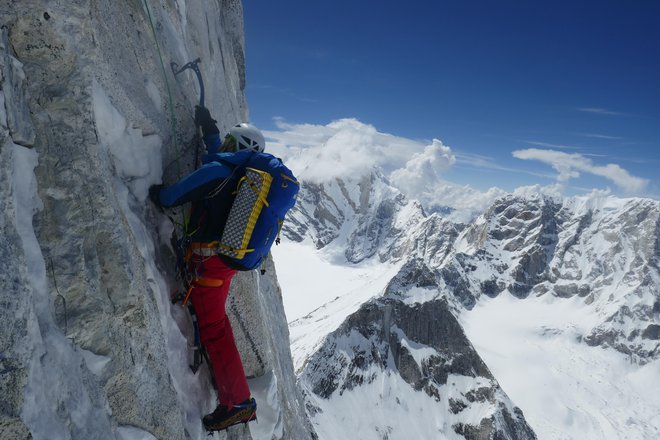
243 0 660 198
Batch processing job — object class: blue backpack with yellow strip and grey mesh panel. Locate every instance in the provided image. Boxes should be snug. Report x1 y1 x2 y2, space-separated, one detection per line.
217 153 300 270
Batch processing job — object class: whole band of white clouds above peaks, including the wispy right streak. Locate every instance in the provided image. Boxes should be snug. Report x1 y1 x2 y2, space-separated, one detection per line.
264 118 649 221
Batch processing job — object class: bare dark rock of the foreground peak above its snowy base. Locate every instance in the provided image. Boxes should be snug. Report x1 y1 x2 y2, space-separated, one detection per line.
300 298 536 439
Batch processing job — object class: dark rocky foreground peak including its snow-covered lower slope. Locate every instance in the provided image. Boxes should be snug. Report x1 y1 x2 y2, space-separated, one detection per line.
300 299 535 439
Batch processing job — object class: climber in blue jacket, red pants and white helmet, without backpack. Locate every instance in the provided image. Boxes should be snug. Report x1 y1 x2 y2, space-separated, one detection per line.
149 106 270 431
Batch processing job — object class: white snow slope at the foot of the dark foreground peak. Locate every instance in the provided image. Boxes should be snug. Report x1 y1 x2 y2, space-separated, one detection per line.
307 367 495 440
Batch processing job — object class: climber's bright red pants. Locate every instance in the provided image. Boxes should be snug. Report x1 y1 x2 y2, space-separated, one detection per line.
190 255 250 408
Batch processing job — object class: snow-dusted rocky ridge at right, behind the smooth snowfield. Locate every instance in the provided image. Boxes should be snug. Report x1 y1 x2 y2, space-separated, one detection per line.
443 197 660 363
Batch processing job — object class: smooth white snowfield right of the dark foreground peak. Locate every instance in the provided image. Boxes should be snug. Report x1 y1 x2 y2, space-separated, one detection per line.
460 292 660 440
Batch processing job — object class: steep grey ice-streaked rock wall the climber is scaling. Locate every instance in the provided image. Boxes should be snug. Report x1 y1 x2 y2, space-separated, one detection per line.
0 0 314 440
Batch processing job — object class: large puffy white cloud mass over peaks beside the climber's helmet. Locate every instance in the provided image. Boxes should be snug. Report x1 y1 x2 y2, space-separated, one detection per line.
264 119 505 221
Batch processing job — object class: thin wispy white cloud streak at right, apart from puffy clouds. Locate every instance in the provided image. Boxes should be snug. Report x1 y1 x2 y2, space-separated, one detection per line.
512 148 649 193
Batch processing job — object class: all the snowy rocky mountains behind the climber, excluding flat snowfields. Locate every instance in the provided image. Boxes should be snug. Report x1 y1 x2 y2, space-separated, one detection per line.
284 171 660 440
